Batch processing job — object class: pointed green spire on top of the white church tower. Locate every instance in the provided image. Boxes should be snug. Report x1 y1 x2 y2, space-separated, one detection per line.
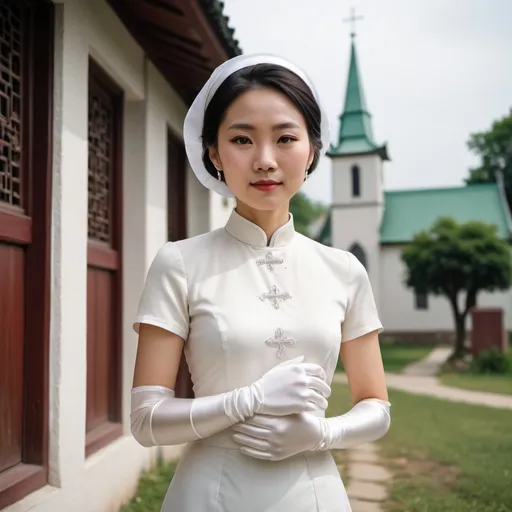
328 29 389 160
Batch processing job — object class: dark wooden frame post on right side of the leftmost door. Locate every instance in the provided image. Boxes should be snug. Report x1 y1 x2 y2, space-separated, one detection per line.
24 2 54 465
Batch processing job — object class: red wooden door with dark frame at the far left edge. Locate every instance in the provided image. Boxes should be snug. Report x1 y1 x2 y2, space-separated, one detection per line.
0 0 53 509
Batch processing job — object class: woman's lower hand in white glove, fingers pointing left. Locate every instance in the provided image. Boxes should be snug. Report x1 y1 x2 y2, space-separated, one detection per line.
231 412 324 461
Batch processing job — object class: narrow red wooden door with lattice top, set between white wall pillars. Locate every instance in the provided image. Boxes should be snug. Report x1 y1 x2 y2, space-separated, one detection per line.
86 61 123 455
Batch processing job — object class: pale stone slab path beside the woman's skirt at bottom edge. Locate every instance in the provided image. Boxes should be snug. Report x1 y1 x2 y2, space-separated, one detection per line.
347 443 391 512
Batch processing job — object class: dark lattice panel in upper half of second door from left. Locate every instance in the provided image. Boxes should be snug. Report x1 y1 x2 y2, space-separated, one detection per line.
88 79 116 245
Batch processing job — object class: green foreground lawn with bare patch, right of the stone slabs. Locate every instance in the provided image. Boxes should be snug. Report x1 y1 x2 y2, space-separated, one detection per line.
328 384 512 512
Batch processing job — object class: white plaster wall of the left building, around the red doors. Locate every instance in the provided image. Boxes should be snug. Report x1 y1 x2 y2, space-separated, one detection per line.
5 0 186 512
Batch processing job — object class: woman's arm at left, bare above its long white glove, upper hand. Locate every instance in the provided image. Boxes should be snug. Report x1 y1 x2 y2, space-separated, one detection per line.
131 323 330 446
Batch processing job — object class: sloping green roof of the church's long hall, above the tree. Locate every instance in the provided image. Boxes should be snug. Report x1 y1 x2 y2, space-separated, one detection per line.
380 183 512 244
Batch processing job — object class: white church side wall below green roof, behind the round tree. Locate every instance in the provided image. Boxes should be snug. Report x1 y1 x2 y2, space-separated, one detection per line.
379 246 512 332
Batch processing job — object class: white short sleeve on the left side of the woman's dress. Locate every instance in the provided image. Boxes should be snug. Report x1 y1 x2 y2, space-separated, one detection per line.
133 242 189 340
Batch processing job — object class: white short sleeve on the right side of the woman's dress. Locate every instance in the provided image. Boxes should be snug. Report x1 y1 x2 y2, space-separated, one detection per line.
341 253 382 341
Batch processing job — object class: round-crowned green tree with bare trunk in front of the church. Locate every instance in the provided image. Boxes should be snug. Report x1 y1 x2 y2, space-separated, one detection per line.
402 218 512 358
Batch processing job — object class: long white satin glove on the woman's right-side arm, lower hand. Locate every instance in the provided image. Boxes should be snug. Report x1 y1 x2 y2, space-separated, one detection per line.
232 398 391 461
